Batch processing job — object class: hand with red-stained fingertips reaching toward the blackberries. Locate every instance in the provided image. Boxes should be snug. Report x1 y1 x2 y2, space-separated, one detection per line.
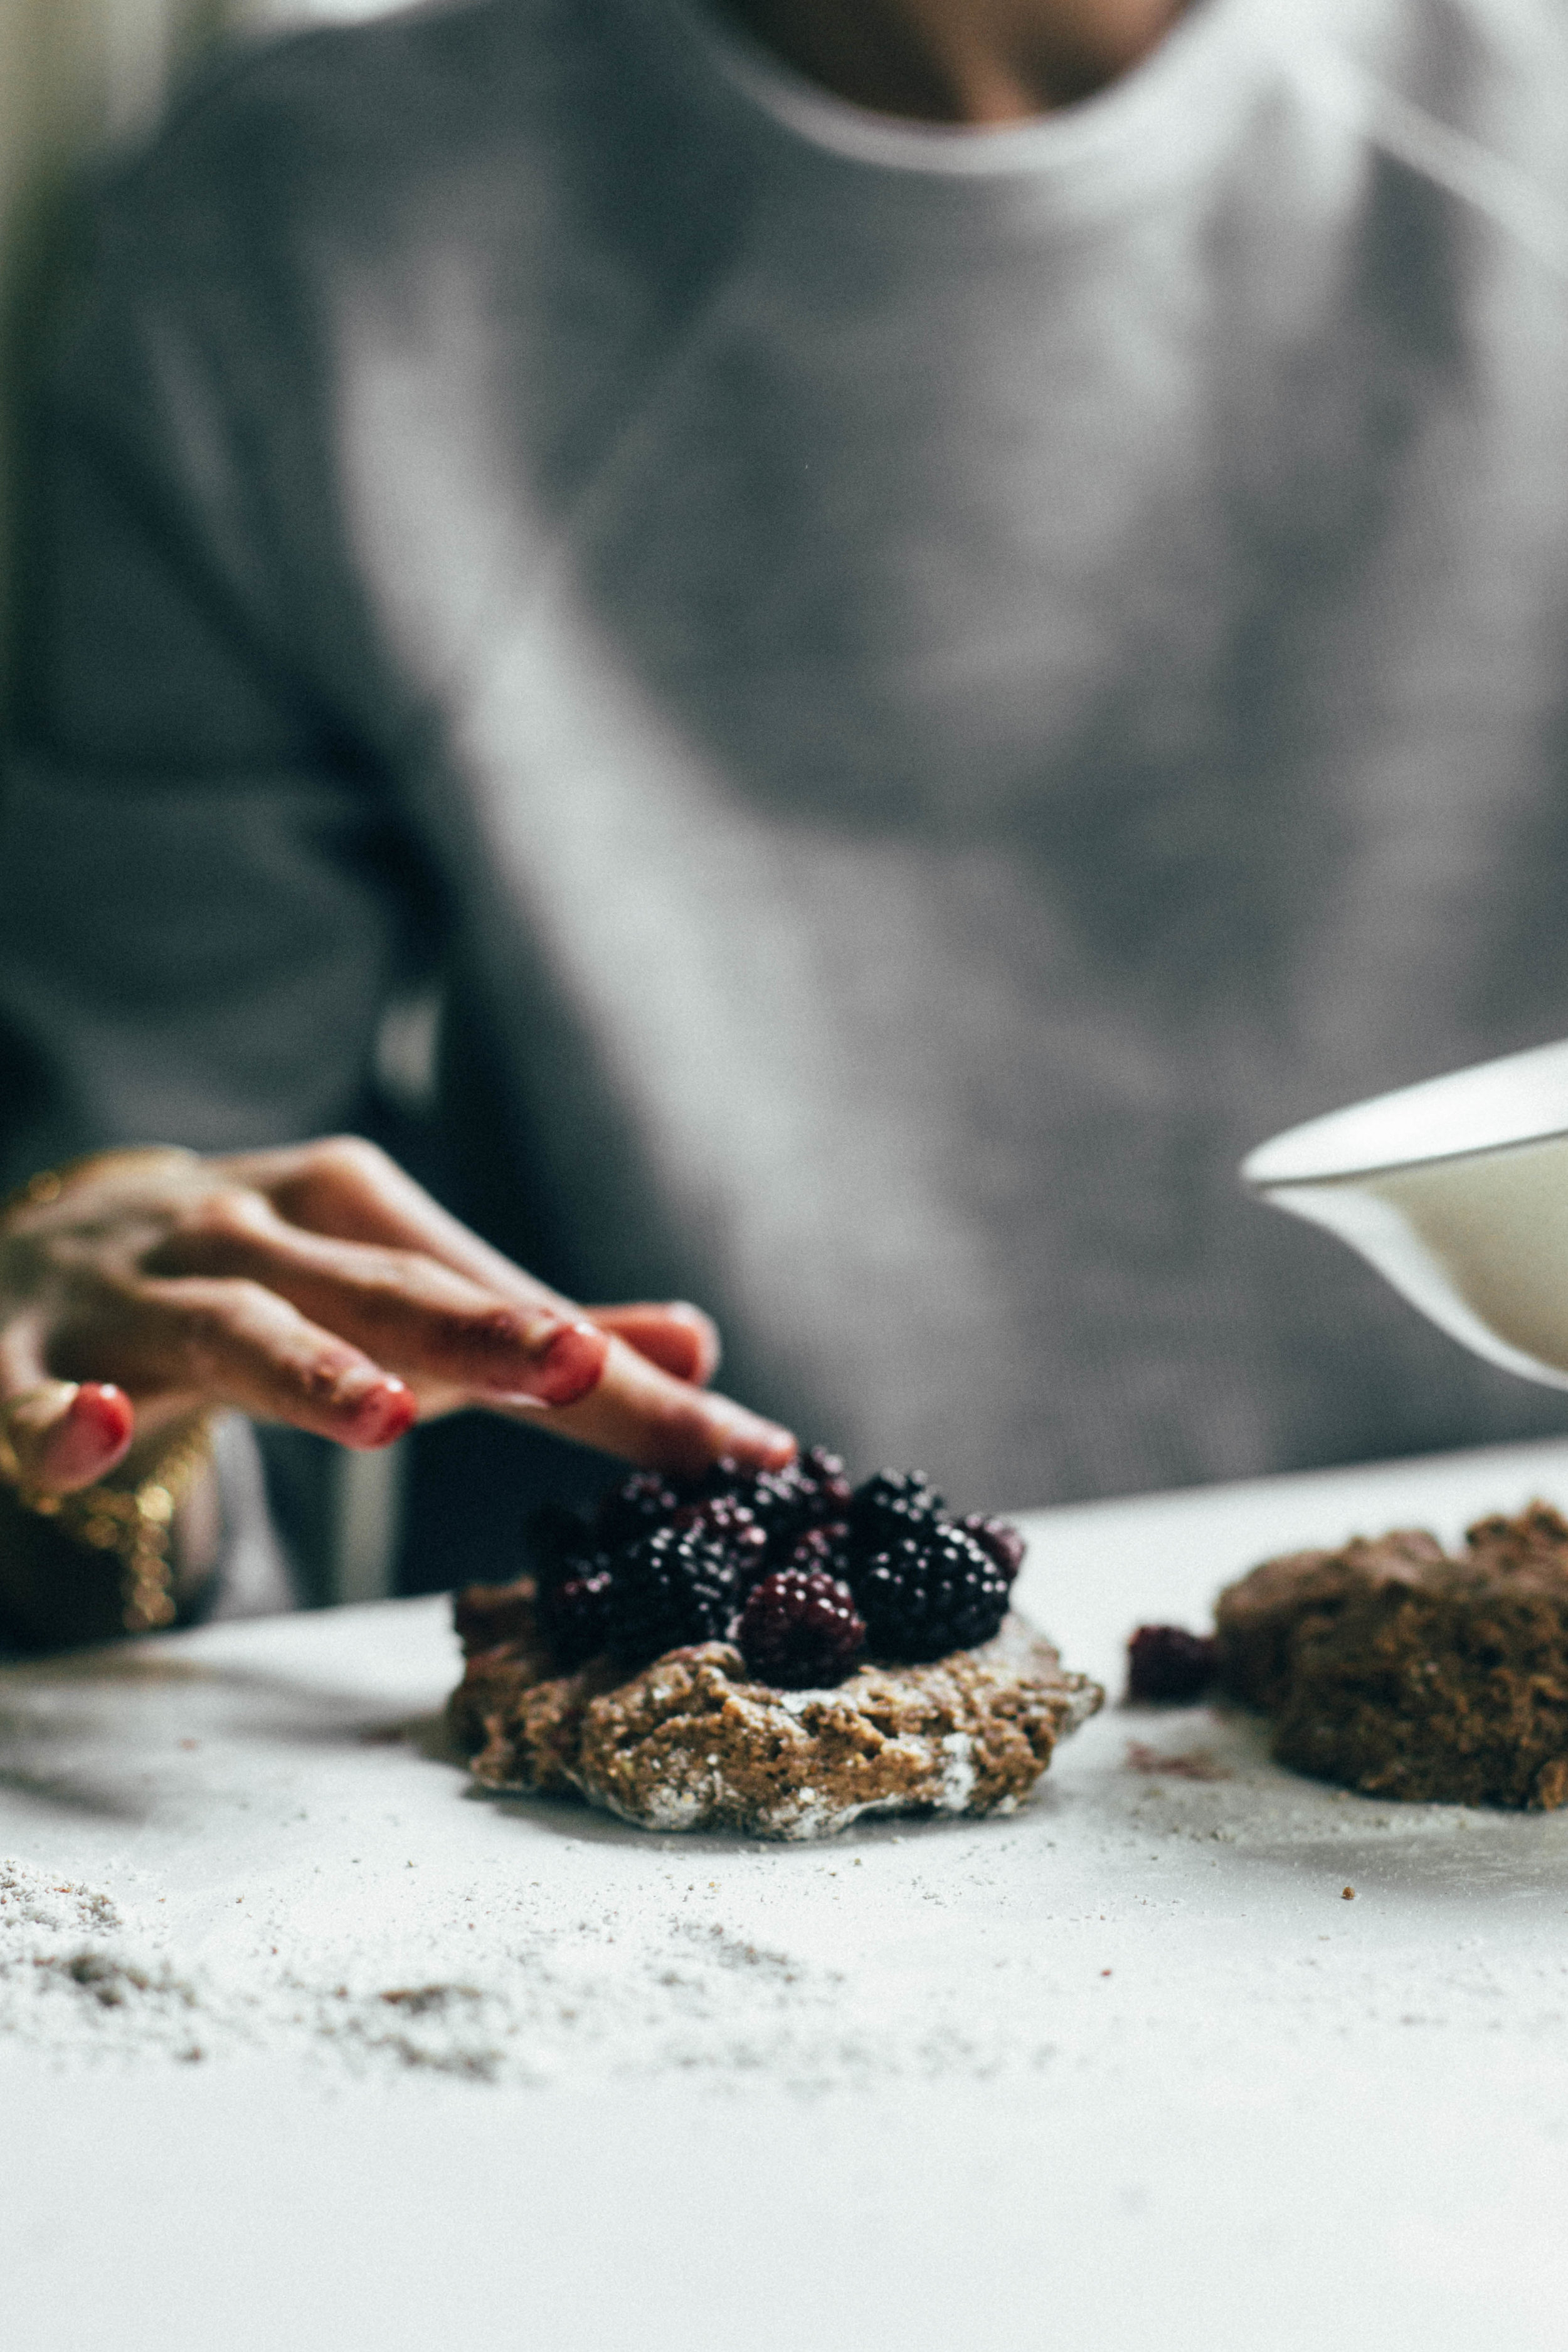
0 1136 795 1493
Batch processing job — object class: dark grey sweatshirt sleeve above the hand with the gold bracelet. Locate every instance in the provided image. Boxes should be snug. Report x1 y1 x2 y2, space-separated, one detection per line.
0 137 433 1181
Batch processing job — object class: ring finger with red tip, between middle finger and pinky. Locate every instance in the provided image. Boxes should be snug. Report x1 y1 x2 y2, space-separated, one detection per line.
54 1279 418 1449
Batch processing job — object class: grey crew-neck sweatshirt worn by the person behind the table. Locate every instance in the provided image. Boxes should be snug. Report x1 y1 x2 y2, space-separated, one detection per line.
0 0 1568 1543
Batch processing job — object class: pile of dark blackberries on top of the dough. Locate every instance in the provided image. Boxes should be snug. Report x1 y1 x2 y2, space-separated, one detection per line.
529 1446 1022 1689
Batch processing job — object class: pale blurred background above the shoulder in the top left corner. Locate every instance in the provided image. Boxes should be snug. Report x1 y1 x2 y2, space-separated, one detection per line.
0 0 393 673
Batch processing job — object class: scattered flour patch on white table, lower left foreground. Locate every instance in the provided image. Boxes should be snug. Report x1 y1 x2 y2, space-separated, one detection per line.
0 1860 1053 2089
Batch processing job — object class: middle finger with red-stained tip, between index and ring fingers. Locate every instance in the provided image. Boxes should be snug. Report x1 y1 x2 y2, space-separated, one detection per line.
144 1185 609 1404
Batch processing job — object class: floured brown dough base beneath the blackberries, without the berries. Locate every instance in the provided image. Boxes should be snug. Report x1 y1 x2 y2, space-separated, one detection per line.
449 1578 1105 1837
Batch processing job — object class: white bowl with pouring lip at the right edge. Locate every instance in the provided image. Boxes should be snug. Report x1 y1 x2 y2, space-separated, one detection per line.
1241 1042 1568 1388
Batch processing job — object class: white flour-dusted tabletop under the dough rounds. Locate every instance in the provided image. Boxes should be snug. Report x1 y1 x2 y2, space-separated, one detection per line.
0 1446 1568 2352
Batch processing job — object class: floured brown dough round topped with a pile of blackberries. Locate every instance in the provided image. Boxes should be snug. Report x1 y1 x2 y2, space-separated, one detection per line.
452 1449 1105 1837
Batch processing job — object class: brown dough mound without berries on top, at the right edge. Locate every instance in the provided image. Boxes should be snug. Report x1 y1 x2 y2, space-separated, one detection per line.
1216 1503 1568 1811
